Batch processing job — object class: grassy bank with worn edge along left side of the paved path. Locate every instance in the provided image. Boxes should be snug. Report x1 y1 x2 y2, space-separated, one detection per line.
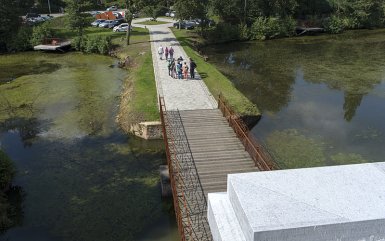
112 28 159 132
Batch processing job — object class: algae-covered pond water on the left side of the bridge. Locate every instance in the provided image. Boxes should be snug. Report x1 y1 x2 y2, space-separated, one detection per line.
0 53 178 241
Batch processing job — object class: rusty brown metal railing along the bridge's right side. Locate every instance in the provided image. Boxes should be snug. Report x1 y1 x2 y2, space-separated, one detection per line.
218 94 279 171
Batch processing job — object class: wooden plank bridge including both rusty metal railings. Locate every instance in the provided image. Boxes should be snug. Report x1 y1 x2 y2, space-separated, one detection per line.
159 96 277 241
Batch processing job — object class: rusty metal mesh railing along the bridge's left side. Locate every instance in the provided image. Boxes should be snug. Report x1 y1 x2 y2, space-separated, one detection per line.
159 97 212 241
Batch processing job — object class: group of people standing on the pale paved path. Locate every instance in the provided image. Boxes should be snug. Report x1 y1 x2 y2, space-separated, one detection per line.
158 46 197 80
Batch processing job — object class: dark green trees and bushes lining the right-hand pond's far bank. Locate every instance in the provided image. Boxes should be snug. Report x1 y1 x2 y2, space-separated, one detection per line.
175 0 385 42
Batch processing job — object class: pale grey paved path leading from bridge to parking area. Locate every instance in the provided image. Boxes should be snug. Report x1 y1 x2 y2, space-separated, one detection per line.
133 18 218 110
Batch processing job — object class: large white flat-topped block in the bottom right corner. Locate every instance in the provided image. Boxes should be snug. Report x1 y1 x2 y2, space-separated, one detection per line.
208 163 385 241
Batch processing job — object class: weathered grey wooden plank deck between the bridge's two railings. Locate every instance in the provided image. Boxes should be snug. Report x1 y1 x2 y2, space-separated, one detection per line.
179 109 258 197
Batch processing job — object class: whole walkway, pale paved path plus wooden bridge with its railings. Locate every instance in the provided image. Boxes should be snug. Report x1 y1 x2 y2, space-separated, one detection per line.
132 19 275 241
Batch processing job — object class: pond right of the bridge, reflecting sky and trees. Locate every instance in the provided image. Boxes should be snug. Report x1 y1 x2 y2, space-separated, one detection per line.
206 30 385 168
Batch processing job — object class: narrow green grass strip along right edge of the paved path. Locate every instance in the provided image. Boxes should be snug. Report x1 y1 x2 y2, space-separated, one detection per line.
172 28 261 116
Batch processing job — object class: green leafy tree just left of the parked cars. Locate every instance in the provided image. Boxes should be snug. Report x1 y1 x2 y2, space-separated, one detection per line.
65 0 91 37
